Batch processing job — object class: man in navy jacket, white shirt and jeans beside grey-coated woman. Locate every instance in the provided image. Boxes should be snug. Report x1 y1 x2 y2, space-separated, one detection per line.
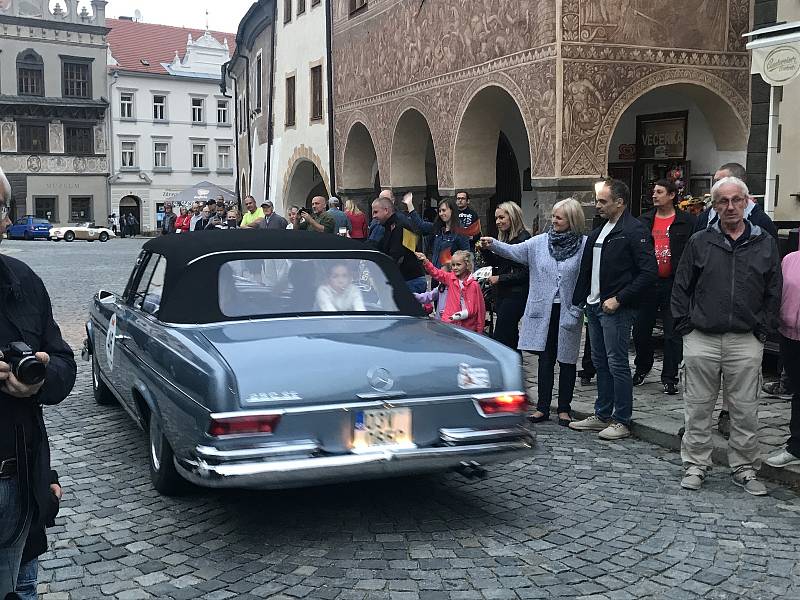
569 179 658 440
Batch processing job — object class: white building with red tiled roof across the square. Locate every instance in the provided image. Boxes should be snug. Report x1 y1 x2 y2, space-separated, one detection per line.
107 18 236 231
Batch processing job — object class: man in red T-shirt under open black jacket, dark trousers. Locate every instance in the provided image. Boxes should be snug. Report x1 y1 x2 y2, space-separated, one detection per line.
633 179 695 395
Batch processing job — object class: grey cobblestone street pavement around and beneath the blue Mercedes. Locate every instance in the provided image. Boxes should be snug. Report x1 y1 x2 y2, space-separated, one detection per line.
2 240 800 600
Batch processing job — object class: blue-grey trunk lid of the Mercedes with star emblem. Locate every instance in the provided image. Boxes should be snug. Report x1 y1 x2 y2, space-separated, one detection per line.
202 317 502 408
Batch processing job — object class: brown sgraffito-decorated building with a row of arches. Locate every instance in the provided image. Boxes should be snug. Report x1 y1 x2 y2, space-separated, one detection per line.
333 0 751 231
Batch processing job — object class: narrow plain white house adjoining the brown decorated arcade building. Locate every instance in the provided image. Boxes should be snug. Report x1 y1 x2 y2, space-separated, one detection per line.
270 0 335 212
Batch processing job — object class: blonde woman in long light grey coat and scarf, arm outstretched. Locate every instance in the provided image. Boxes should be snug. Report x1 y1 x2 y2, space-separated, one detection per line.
481 198 586 426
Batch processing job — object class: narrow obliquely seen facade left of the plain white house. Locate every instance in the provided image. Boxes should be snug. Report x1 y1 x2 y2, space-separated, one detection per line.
224 0 276 204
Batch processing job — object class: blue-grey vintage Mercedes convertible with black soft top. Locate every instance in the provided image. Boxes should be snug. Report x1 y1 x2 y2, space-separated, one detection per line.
83 230 534 494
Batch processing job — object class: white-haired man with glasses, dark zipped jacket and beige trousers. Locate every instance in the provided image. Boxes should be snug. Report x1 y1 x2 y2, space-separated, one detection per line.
672 177 782 496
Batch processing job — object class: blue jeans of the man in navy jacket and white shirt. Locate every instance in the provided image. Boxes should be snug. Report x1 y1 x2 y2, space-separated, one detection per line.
586 304 637 426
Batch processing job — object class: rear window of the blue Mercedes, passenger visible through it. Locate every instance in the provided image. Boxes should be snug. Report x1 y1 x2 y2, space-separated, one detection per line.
219 258 399 317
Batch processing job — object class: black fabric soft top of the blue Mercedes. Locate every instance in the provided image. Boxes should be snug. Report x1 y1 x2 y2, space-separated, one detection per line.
143 229 423 323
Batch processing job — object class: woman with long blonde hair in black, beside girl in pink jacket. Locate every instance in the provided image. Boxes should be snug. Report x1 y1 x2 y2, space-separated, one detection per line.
478 202 531 349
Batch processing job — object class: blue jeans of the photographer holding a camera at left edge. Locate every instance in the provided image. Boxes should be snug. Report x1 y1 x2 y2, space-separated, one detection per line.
0 477 30 598
